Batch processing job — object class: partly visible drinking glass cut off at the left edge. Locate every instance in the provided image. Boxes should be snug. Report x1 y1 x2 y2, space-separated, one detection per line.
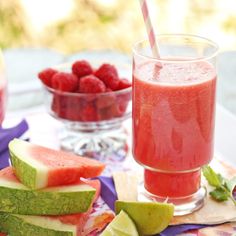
0 49 6 126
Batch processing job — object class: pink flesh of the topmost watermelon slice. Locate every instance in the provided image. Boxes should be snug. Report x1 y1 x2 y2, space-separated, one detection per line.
28 144 105 186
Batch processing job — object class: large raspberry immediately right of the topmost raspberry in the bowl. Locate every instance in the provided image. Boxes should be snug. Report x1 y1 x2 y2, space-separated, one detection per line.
94 64 119 90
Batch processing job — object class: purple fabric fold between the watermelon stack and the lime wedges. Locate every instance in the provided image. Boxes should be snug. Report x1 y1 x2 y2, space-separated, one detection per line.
98 176 117 211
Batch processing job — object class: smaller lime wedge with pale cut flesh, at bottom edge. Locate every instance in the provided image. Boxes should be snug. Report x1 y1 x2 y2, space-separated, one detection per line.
100 211 138 236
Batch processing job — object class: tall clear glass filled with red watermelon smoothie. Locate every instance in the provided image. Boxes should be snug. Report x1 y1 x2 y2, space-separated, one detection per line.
133 35 218 215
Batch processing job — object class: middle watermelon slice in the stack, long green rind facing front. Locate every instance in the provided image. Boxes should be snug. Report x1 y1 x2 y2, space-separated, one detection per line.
0 167 96 215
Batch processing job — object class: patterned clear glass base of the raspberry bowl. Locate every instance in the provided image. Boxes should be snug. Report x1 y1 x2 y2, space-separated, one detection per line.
60 124 128 162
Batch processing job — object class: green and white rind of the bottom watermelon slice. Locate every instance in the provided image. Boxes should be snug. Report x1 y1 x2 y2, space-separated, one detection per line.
0 212 77 236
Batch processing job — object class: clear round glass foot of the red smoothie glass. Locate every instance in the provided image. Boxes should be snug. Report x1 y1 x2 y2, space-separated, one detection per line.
138 183 207 216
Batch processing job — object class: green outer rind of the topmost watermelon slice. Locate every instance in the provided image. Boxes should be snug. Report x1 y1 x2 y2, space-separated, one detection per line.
10 150 37 189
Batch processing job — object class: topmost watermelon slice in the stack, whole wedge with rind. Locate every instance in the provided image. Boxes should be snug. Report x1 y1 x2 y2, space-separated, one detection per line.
9 139 105 189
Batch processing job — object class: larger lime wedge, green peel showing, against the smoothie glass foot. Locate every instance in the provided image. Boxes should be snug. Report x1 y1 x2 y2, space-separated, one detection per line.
115 201 174 235
